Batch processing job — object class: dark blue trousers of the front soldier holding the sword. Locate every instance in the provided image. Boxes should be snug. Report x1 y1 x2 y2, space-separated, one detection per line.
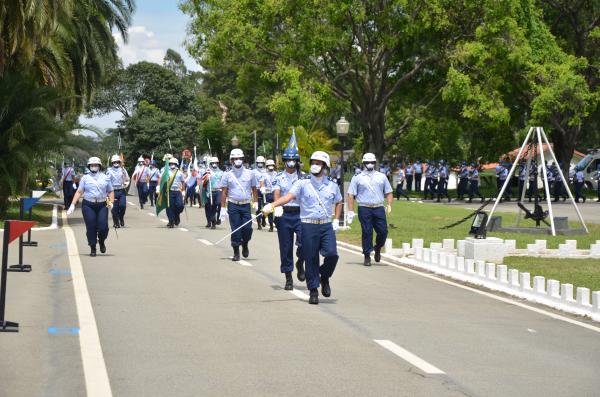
301 223 339 289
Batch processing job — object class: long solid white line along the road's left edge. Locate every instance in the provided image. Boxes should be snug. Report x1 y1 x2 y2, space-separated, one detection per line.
62 211 112 397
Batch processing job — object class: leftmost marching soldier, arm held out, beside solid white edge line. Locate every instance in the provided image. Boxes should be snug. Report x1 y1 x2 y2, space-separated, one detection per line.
67 157 115 256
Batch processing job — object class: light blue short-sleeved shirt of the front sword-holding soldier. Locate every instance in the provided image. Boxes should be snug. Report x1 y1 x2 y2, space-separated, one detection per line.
290 175 342 220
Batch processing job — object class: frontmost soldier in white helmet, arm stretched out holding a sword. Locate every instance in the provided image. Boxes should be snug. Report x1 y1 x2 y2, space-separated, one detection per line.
263 151 343 305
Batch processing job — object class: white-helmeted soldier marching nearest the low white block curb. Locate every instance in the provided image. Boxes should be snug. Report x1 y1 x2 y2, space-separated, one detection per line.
348 153 394 266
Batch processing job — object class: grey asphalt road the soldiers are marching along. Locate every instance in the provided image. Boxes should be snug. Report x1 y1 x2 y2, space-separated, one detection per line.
0 197 600 397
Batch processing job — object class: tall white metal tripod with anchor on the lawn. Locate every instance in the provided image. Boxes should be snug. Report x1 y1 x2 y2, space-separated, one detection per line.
486 127 589 236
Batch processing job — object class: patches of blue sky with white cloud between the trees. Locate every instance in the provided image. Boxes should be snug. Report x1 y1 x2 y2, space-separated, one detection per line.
81 0 200 128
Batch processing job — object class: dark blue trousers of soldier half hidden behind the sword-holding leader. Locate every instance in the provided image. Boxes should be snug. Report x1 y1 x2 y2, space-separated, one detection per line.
275 212 304 273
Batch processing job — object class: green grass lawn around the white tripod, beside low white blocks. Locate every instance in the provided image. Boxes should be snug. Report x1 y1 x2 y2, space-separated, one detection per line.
338 200 600 291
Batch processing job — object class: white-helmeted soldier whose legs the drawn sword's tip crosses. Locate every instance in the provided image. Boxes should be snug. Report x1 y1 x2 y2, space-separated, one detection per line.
221 149 260 261
